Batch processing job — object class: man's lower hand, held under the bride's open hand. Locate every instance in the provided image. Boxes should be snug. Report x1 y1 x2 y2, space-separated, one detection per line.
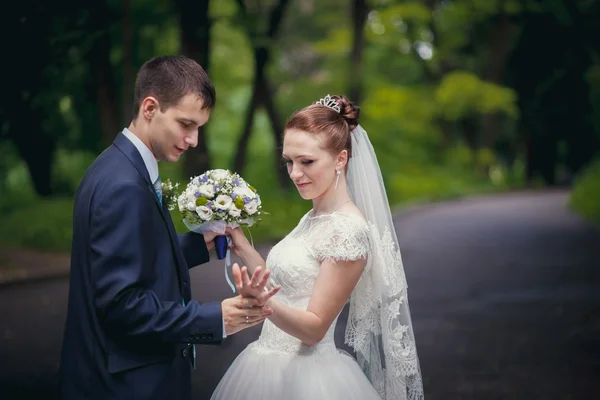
221 296 273 336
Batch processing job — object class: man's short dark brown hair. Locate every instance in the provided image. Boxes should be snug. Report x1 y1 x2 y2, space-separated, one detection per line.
133 56 216 120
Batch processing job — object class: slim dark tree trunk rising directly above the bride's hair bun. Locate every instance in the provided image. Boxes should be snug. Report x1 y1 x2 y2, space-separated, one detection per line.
348 0 369 104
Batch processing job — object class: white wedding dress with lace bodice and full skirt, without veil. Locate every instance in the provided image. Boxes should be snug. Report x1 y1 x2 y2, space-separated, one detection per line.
211 212 381 400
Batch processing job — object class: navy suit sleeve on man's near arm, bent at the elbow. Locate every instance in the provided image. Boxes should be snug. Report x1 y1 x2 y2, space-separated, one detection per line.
90 182 223 343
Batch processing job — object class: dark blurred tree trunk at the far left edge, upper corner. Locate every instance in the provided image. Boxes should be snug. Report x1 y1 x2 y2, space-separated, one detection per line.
0 1 56 197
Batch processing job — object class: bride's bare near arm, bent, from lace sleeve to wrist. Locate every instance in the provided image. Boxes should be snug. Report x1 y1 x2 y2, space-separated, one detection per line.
239 259 366 346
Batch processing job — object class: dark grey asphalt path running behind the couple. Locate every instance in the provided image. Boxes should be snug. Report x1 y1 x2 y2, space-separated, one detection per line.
0 192 600 400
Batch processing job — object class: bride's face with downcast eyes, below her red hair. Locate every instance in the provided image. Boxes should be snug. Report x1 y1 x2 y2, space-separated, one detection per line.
282 129 336 200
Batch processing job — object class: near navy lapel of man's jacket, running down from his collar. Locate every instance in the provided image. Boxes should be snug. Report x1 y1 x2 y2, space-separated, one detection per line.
113 133 188 296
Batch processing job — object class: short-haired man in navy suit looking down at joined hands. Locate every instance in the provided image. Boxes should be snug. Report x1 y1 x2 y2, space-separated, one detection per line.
59 56 274 400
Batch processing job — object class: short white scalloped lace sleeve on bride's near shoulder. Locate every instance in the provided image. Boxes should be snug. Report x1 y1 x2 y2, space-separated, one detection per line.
311 215 369 261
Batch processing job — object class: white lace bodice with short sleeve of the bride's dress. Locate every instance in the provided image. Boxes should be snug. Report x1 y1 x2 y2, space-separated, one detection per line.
252 212 369 355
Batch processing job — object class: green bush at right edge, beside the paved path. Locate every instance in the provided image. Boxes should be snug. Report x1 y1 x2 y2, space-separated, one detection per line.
569 158 600 224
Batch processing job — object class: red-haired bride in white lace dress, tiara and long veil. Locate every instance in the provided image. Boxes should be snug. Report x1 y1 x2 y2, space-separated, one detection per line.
212 95 423 400
